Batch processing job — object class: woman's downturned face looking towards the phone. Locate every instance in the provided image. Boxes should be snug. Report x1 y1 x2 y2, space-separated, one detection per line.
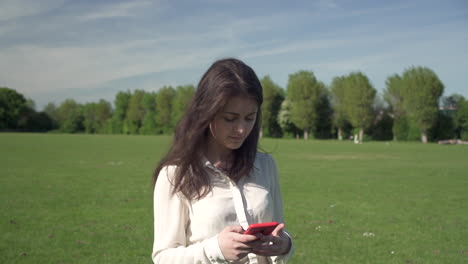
210 96 258 150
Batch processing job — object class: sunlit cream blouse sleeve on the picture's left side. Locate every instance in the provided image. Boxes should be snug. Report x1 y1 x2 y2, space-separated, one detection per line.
151 166 228 264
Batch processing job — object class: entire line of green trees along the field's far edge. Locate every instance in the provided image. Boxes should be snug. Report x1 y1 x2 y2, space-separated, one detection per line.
0 67 468 143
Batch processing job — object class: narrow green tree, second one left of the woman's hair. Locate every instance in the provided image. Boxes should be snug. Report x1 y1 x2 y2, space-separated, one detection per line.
156 86 176 134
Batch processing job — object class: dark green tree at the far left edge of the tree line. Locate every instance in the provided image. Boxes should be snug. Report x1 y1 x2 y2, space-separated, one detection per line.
0 87 27 129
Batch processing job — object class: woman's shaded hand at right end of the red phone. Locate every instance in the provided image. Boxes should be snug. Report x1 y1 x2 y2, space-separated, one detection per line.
252 224 291 256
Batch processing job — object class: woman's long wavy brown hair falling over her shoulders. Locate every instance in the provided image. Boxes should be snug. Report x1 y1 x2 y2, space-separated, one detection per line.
153 58 263 200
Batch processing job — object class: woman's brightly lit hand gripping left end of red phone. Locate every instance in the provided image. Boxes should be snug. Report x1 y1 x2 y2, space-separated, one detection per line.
218 226 264 260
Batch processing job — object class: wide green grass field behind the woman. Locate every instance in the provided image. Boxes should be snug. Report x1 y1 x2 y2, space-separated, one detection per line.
0 134 468 264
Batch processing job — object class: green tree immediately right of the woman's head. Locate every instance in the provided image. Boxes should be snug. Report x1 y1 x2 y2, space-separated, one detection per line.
260 75 284 137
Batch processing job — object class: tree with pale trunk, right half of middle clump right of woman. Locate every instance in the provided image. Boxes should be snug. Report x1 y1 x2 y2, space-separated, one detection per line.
344 72 376 142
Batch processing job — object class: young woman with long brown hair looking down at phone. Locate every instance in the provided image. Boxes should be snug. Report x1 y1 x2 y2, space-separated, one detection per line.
152 59 294 264
